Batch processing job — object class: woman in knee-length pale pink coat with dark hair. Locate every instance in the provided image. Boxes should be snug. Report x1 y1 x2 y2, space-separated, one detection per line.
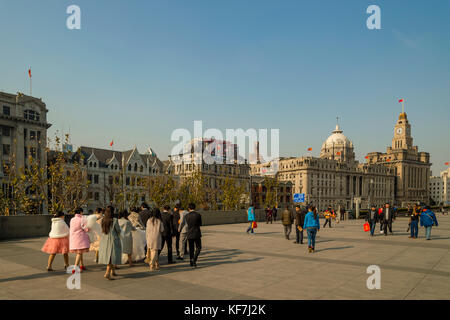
70 208 91 271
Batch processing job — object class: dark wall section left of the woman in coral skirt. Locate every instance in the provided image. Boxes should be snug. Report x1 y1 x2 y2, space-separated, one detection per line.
0 215 52 240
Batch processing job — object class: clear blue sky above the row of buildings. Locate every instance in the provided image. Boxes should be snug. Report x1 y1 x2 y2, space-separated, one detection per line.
0 0 450 174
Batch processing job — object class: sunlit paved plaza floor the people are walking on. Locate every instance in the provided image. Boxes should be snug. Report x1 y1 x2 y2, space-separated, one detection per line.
0 214 450 299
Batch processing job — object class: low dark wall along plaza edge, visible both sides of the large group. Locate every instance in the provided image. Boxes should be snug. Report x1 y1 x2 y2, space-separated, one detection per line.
0 210 265 240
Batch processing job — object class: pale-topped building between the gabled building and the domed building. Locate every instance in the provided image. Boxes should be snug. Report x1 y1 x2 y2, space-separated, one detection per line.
169 138 250 207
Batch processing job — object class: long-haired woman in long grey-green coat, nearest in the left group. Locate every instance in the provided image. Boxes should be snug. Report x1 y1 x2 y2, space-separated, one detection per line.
98 206 122 280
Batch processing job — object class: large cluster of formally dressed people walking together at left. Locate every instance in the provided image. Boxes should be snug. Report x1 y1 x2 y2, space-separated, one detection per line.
42 202 202 280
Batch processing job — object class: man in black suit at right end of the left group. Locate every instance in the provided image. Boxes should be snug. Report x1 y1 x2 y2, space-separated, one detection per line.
179 203 202 267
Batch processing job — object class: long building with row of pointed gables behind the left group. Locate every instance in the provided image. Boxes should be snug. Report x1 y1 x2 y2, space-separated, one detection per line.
73 147 164 210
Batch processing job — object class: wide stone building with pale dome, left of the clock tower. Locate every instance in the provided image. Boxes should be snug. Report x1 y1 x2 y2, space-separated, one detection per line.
251 125 395 210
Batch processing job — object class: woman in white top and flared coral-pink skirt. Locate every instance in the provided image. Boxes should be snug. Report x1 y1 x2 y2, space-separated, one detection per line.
41 211 69 271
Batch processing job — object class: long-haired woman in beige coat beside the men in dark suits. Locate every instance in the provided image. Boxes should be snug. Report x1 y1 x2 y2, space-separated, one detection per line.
146 208 164 271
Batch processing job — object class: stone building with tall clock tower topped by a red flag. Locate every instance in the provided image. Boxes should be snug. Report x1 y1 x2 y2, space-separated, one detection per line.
367 112 431 207
